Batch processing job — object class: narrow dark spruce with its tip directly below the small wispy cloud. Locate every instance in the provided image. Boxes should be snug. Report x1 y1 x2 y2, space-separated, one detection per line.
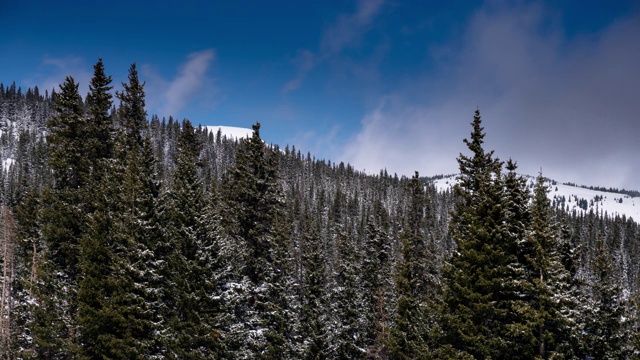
163 120 225 359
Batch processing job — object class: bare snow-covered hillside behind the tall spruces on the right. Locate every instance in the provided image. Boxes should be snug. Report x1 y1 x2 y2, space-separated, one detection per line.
433 175 640 221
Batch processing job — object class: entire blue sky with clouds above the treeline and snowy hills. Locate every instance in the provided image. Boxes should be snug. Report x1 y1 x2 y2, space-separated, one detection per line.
0 0 640 189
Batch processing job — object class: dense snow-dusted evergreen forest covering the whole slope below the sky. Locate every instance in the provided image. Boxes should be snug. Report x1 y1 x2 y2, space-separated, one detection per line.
0 60 640 359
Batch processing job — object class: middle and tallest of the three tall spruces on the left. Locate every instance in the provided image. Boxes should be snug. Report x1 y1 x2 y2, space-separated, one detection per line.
78 59 132 358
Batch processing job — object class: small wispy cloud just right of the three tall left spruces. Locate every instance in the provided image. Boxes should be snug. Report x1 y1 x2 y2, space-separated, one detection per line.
142 49 215 116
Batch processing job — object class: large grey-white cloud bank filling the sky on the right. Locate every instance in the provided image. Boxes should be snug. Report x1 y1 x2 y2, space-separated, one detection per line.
342 3 640 188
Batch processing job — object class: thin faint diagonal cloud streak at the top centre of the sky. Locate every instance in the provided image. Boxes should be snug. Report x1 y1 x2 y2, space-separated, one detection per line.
282 0 384 94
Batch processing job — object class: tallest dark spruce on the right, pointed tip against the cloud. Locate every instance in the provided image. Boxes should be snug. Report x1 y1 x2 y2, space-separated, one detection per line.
443 111 516 358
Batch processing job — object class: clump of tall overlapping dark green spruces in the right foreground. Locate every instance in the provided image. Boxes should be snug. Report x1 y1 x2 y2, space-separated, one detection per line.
442 112 576 359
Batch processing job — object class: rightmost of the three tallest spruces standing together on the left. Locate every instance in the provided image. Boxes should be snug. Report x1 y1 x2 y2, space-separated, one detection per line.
105 64 166 358
